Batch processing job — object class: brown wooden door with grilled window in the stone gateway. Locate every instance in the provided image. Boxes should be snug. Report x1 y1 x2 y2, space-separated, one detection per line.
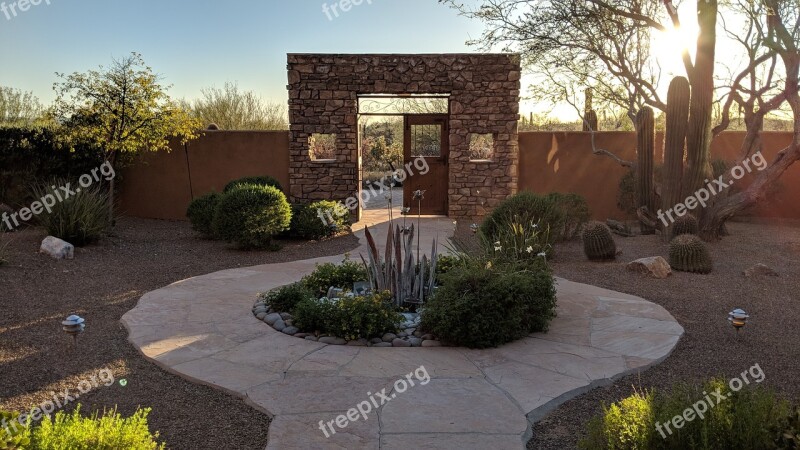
403 114 450 216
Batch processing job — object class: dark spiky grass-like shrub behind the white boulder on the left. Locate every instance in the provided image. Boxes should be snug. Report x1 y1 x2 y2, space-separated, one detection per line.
33 180 110 247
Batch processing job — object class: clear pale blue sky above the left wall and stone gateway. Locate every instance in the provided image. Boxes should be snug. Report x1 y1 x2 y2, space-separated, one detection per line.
0 0 482 103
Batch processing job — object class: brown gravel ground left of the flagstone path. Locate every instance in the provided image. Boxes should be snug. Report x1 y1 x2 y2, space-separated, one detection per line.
0 219 358 450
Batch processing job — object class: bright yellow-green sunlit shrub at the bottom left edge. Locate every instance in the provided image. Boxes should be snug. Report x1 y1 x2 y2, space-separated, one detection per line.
31 406 165 450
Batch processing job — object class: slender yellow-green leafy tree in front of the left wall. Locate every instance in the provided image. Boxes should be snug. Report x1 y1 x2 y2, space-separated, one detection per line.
53 53 201 223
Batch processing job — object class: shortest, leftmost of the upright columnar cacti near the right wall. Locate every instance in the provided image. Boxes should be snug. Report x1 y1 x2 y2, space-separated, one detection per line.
636 106 656 234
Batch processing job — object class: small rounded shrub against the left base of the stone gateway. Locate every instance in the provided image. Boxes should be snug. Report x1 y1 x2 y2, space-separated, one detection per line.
288 200 350 240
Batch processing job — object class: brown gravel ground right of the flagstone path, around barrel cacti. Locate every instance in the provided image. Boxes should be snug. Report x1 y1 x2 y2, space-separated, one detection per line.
459 223 800 450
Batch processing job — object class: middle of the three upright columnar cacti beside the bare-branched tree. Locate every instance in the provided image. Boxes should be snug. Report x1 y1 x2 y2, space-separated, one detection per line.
661 77 690 240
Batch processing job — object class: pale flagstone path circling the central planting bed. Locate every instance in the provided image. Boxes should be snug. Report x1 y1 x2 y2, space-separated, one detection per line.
122 216 683 450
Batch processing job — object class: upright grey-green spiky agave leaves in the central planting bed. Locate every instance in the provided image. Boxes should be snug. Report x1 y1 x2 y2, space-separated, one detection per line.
361 223 438 307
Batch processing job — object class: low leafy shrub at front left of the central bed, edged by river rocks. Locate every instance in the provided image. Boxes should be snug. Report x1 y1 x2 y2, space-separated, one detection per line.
324 292 403 341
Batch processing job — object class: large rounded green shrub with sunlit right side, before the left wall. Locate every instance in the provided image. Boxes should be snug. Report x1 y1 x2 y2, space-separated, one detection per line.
212 184 292 248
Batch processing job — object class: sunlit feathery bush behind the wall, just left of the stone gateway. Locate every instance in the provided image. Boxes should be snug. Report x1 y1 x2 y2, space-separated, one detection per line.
191 83 289 130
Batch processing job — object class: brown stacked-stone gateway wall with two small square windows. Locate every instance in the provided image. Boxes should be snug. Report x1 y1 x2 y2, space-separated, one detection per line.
287 54 521 219
